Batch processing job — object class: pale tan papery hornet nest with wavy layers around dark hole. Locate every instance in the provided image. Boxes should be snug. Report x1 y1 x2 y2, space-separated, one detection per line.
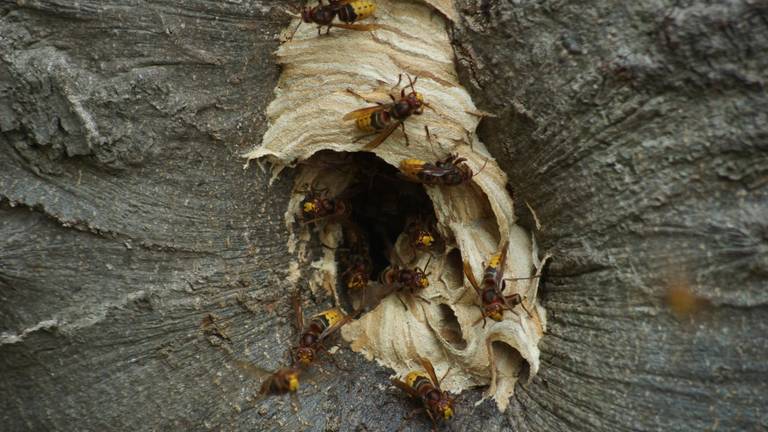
246 0 546 410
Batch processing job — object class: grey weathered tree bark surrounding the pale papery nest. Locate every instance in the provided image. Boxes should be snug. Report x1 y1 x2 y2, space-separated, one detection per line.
0 0 768 431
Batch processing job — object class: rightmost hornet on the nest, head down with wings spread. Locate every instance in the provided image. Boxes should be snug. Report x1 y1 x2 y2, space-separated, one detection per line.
464 242 532 327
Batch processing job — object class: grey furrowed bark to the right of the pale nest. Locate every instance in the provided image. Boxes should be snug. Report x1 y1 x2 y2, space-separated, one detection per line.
455 1 768 430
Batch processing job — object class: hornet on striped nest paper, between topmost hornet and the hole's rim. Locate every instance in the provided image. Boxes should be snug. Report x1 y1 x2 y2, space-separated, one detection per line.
342 74 430 150
